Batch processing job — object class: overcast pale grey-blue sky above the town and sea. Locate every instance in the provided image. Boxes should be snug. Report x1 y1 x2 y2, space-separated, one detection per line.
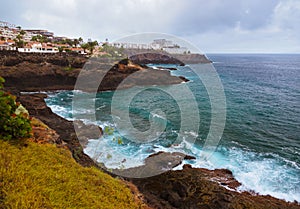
0 0 300 53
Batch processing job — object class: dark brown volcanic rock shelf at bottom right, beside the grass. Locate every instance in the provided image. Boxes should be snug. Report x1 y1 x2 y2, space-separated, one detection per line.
131 166 300 209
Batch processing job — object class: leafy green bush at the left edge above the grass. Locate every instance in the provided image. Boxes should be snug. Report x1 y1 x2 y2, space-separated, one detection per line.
0 77 31 140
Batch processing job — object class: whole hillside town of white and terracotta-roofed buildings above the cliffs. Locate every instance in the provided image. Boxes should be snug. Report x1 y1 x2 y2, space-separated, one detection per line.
0 21 190 56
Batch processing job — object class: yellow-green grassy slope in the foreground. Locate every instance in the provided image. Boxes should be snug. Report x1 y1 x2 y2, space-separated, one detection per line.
0 140 143 209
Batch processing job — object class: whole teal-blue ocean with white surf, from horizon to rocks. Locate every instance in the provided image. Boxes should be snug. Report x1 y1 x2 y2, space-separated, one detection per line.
46 54 300 202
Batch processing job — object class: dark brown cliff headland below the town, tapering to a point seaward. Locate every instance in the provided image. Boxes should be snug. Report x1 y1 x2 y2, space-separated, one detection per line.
0 51 186 91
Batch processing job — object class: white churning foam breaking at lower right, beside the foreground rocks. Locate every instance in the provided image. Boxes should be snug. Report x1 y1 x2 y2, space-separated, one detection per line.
190 148 300 202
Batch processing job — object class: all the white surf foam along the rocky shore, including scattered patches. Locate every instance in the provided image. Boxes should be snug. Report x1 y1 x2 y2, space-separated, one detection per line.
45 91 300 202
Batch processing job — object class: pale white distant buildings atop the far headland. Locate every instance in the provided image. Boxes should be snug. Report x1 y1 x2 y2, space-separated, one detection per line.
110 39 189 54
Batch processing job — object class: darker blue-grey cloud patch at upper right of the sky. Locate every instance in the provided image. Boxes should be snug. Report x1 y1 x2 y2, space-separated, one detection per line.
169 0 279 34
